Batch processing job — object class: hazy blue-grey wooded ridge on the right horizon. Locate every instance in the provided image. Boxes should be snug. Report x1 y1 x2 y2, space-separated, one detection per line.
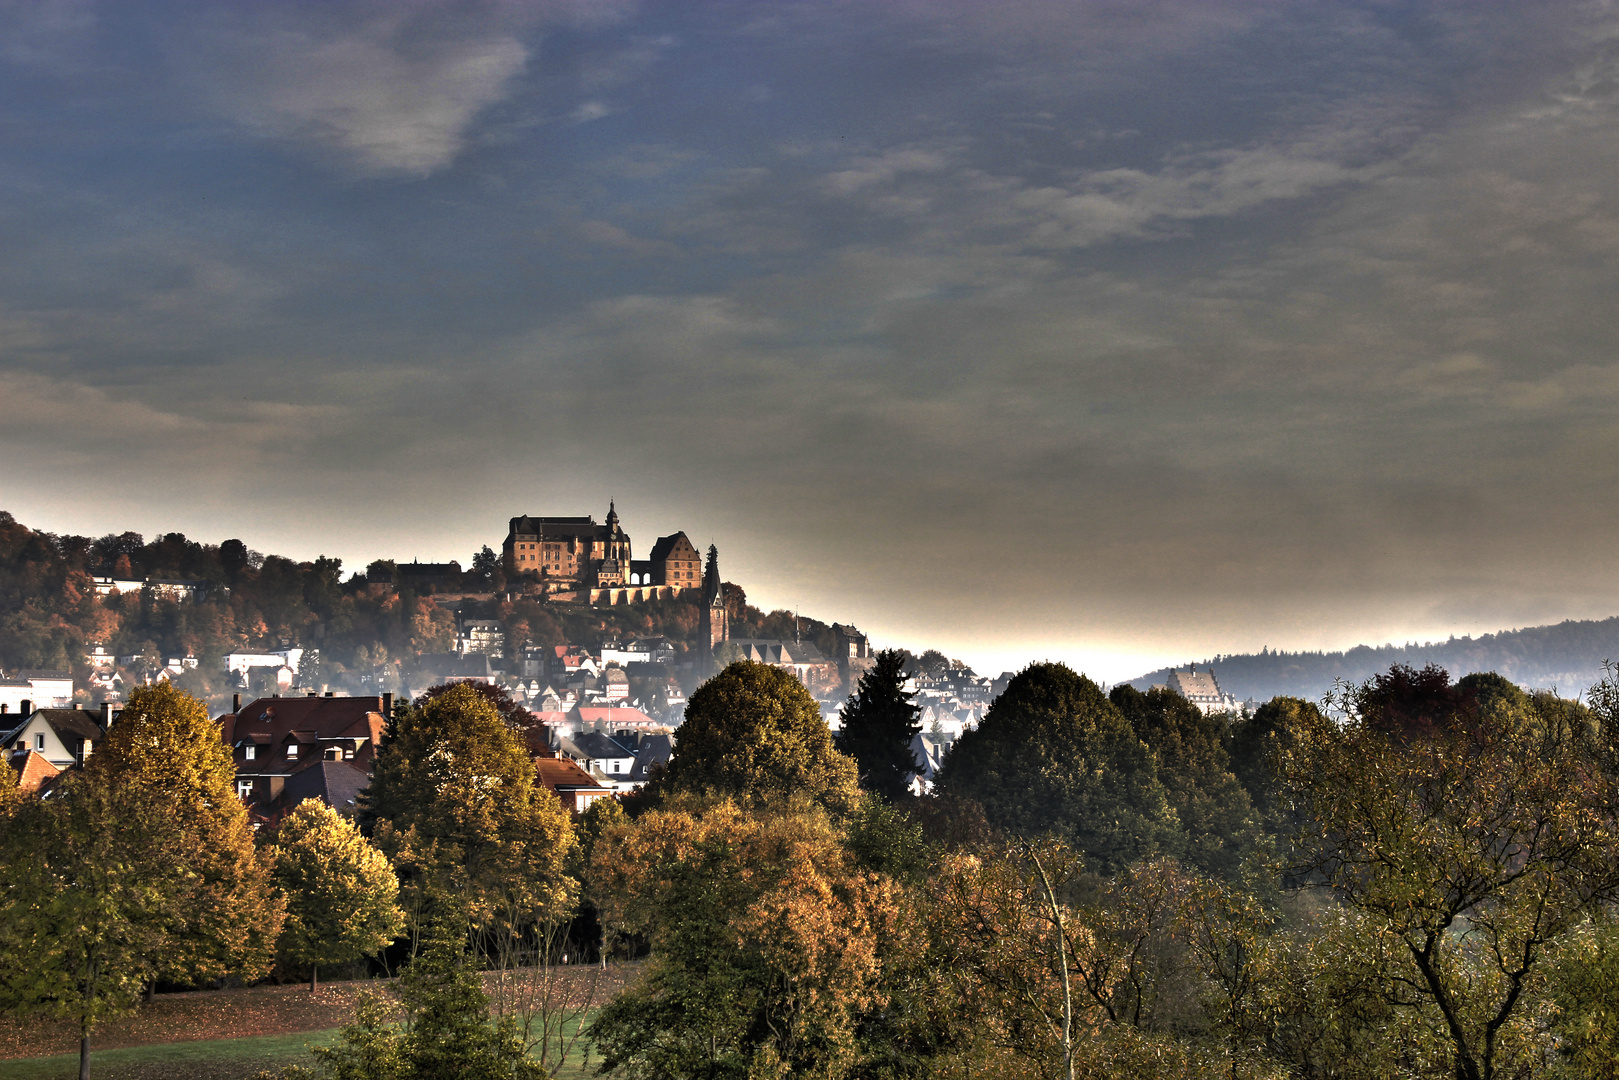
1128 615 1619 701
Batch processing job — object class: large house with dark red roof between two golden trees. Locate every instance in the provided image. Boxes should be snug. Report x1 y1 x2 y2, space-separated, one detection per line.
215 693 393 823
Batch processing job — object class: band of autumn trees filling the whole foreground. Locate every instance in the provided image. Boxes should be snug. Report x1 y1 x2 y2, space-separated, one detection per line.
0 653 1619 1080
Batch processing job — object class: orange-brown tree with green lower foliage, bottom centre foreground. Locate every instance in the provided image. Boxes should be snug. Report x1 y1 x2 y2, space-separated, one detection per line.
591 797 907 1080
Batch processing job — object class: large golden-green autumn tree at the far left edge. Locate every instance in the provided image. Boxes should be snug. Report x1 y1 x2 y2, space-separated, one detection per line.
0 683 282 1077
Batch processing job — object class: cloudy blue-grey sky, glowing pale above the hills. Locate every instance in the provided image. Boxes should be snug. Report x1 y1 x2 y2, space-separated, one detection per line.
0 0 1619 680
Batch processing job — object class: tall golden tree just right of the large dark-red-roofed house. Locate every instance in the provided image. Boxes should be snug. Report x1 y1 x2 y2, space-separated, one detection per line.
363 683 576 936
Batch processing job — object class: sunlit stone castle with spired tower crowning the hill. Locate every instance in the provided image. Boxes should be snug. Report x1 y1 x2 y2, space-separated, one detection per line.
500 502 703 604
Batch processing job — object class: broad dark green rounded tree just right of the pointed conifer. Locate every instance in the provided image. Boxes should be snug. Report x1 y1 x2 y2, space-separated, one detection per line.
936 664 1177 871
